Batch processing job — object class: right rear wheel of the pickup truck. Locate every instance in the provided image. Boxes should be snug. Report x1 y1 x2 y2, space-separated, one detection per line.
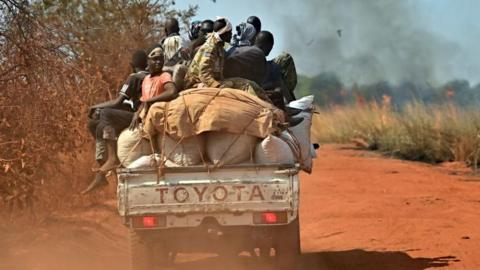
275 218 301 270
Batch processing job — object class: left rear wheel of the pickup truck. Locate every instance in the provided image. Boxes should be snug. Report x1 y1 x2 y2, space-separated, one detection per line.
130 230 154 270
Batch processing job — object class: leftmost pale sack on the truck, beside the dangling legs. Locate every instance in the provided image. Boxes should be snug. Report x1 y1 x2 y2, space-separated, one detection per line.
117 128 152 167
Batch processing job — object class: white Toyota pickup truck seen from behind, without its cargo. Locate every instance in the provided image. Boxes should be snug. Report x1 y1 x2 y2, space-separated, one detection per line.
117 164 300 270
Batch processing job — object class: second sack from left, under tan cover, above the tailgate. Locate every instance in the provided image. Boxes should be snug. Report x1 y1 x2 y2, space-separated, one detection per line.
157 134 205 166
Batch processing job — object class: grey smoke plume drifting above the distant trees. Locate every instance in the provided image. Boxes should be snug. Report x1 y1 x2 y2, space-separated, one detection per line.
262 0 460 83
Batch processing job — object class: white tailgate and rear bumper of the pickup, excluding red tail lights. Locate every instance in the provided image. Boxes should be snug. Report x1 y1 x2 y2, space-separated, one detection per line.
118 164 299 229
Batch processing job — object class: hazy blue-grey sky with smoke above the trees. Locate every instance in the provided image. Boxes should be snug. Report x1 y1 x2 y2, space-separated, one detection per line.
176 0 480 84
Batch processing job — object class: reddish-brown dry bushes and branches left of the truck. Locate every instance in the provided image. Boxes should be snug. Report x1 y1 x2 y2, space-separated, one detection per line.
0 0 196 217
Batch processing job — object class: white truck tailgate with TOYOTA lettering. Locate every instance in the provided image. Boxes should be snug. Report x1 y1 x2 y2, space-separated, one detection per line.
118 167 296 216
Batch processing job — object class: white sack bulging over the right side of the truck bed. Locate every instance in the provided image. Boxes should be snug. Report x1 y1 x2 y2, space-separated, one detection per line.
288 95 313 173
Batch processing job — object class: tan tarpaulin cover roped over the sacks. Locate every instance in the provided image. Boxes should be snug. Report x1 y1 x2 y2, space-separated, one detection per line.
143 88 284 139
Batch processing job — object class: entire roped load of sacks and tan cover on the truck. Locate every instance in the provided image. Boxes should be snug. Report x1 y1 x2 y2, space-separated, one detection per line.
118 88 313 172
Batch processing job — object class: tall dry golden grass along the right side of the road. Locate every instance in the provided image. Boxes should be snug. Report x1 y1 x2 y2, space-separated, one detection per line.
312 100 480 165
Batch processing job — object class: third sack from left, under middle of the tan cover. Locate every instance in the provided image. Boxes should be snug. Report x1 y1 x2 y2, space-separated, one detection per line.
206 131 258 166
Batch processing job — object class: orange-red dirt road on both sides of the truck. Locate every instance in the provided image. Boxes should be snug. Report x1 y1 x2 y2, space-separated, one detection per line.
0 145 480 270
